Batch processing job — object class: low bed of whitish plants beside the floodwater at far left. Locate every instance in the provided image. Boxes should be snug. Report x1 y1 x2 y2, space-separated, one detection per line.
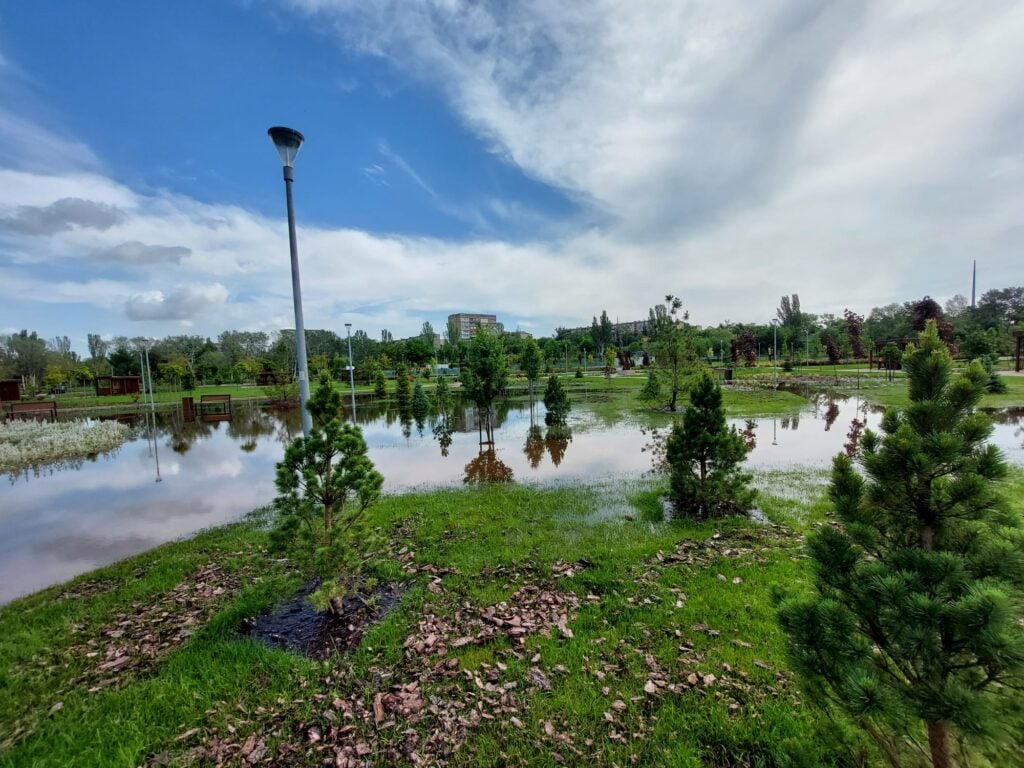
0 421 131 472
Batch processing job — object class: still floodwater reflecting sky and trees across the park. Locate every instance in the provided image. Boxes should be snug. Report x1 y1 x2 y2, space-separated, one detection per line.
0 396 1024 602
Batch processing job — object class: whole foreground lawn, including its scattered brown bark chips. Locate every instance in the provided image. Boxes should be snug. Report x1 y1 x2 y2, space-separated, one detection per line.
0 473 884 766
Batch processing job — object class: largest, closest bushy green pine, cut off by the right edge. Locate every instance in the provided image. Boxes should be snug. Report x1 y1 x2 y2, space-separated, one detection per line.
779 321 1024 768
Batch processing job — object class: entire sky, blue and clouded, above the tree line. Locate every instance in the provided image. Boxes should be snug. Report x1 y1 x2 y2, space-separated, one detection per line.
0 0 1024 351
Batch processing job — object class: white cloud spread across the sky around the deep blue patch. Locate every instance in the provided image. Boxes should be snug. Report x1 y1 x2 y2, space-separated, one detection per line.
0 0 1024 342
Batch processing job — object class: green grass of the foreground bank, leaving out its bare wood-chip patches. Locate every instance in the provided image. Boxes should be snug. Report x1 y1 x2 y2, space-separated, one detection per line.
0 480 884 766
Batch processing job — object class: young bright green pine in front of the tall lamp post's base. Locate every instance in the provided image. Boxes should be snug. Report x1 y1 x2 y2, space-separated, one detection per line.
272 386 384 586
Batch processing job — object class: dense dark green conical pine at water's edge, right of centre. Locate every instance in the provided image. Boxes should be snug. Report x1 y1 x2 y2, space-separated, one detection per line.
666 371 754 517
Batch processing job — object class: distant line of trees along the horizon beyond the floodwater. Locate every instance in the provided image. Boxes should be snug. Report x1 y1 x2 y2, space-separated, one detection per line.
0 287 1024 393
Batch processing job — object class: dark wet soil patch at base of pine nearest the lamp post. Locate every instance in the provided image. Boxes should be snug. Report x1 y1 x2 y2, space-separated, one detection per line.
243 581 406 659
